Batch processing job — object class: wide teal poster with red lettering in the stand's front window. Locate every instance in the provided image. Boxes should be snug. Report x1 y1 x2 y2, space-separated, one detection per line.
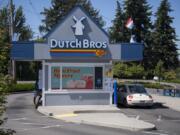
62 67 94 89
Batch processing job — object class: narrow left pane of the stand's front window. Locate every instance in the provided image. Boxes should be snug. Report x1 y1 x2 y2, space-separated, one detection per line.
51 66 61 89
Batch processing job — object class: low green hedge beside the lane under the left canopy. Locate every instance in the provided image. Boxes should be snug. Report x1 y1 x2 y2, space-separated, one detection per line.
10 83 35 92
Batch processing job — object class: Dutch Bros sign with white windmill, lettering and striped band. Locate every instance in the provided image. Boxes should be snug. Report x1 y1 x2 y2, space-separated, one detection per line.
49 15 108 57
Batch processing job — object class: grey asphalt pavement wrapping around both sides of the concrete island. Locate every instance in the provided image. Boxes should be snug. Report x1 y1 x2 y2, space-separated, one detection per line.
4 93 180 135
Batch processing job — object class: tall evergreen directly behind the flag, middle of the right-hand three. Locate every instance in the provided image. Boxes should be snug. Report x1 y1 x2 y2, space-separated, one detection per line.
124 0 153 70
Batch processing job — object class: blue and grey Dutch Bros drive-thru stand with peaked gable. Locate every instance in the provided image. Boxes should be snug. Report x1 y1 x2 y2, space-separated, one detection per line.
11 6 143 106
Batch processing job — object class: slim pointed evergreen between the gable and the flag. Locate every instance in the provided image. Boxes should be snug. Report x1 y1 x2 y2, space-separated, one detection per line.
109 1 128 43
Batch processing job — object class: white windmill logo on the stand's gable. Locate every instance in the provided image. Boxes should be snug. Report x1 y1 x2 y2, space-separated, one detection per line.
72 16 86 36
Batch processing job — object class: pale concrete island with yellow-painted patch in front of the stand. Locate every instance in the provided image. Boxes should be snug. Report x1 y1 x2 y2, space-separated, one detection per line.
38 105 155 130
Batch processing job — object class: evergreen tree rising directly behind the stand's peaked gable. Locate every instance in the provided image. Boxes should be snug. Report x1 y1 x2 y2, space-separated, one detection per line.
39 0 104 32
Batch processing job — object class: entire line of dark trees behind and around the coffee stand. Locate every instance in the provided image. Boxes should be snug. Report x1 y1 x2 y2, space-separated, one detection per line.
0 0 179 80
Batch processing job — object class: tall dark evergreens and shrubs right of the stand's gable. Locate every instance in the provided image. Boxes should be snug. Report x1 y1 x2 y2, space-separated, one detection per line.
109 0 179 78
